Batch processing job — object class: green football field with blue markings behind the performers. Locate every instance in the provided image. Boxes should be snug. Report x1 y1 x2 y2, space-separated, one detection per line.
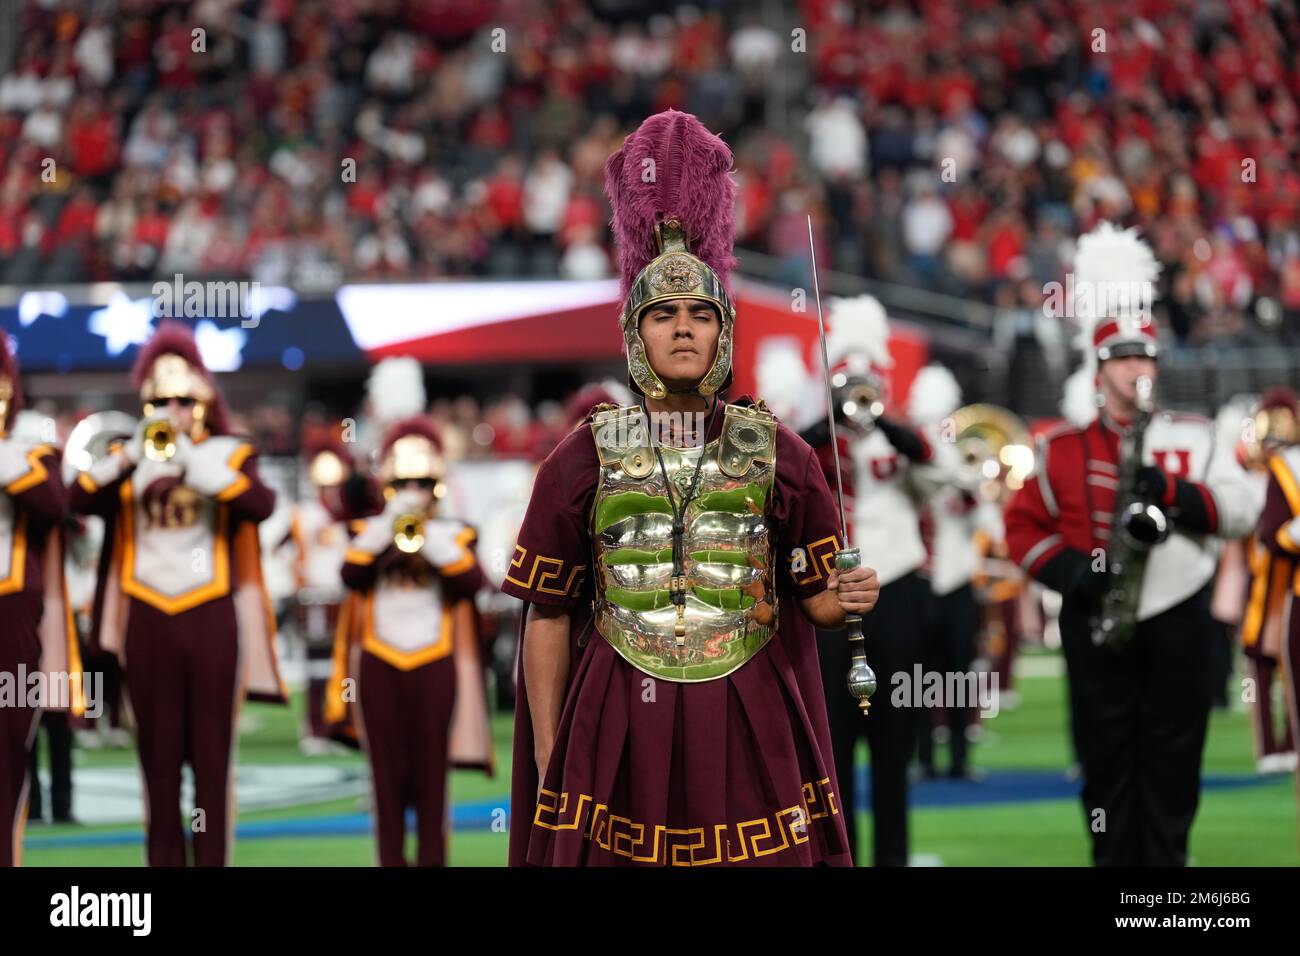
23 654 1300 866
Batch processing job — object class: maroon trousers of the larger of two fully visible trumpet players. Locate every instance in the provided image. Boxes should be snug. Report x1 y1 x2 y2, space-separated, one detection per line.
126 597 242 866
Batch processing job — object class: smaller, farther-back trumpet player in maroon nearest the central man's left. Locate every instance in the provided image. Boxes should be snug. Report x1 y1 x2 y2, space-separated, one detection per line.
325 418 493 866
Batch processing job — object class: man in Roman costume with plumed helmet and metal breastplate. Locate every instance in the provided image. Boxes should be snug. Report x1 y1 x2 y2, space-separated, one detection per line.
503 109 875 866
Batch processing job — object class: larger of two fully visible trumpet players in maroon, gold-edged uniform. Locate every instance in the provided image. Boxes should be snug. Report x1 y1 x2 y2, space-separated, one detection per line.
70 320 287 866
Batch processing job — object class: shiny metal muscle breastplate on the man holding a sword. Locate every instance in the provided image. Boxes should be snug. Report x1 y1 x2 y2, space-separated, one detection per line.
590 403 776 683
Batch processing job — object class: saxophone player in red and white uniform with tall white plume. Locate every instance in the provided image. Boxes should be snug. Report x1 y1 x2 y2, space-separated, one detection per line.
1006 222 1260 866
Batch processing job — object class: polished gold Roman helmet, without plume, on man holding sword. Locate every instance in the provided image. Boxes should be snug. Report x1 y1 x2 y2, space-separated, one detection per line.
619 219 736 398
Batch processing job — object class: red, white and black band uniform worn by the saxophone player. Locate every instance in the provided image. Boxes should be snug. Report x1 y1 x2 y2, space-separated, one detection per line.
1006 224 1258 866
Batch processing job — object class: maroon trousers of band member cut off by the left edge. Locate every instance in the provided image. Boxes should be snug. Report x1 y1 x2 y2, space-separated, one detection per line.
0 591 42 866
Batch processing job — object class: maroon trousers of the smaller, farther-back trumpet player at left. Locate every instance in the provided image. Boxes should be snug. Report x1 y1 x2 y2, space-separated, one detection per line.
356 650 456 866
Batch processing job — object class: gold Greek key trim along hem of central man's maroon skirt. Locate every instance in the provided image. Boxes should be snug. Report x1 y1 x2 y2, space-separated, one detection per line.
533 777 840 866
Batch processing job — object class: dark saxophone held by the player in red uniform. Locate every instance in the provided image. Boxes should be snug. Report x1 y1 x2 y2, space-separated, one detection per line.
1092 376 1169 649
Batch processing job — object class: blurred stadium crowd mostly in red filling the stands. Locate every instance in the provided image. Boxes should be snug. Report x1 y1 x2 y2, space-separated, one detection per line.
0 0 1300 345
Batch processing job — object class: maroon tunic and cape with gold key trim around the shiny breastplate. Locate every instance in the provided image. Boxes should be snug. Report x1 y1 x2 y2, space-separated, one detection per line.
503 399 853 866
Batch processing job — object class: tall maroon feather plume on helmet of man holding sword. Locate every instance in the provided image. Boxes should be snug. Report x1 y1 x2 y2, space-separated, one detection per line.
605 109 736 299
